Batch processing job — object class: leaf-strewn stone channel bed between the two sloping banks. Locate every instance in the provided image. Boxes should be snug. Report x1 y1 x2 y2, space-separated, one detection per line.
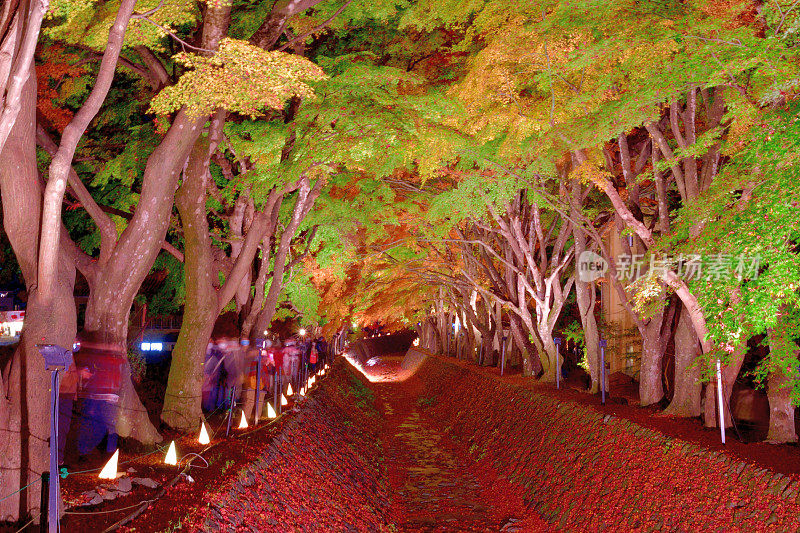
372 376 549 532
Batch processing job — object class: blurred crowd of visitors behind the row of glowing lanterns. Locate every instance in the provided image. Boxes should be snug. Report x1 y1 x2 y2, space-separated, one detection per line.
58 332 331 464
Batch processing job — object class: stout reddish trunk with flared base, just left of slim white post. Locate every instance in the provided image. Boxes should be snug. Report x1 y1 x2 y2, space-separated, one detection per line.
664 307 702 417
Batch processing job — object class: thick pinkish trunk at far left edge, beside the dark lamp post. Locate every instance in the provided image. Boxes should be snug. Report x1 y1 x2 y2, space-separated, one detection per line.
0 77 76 522
